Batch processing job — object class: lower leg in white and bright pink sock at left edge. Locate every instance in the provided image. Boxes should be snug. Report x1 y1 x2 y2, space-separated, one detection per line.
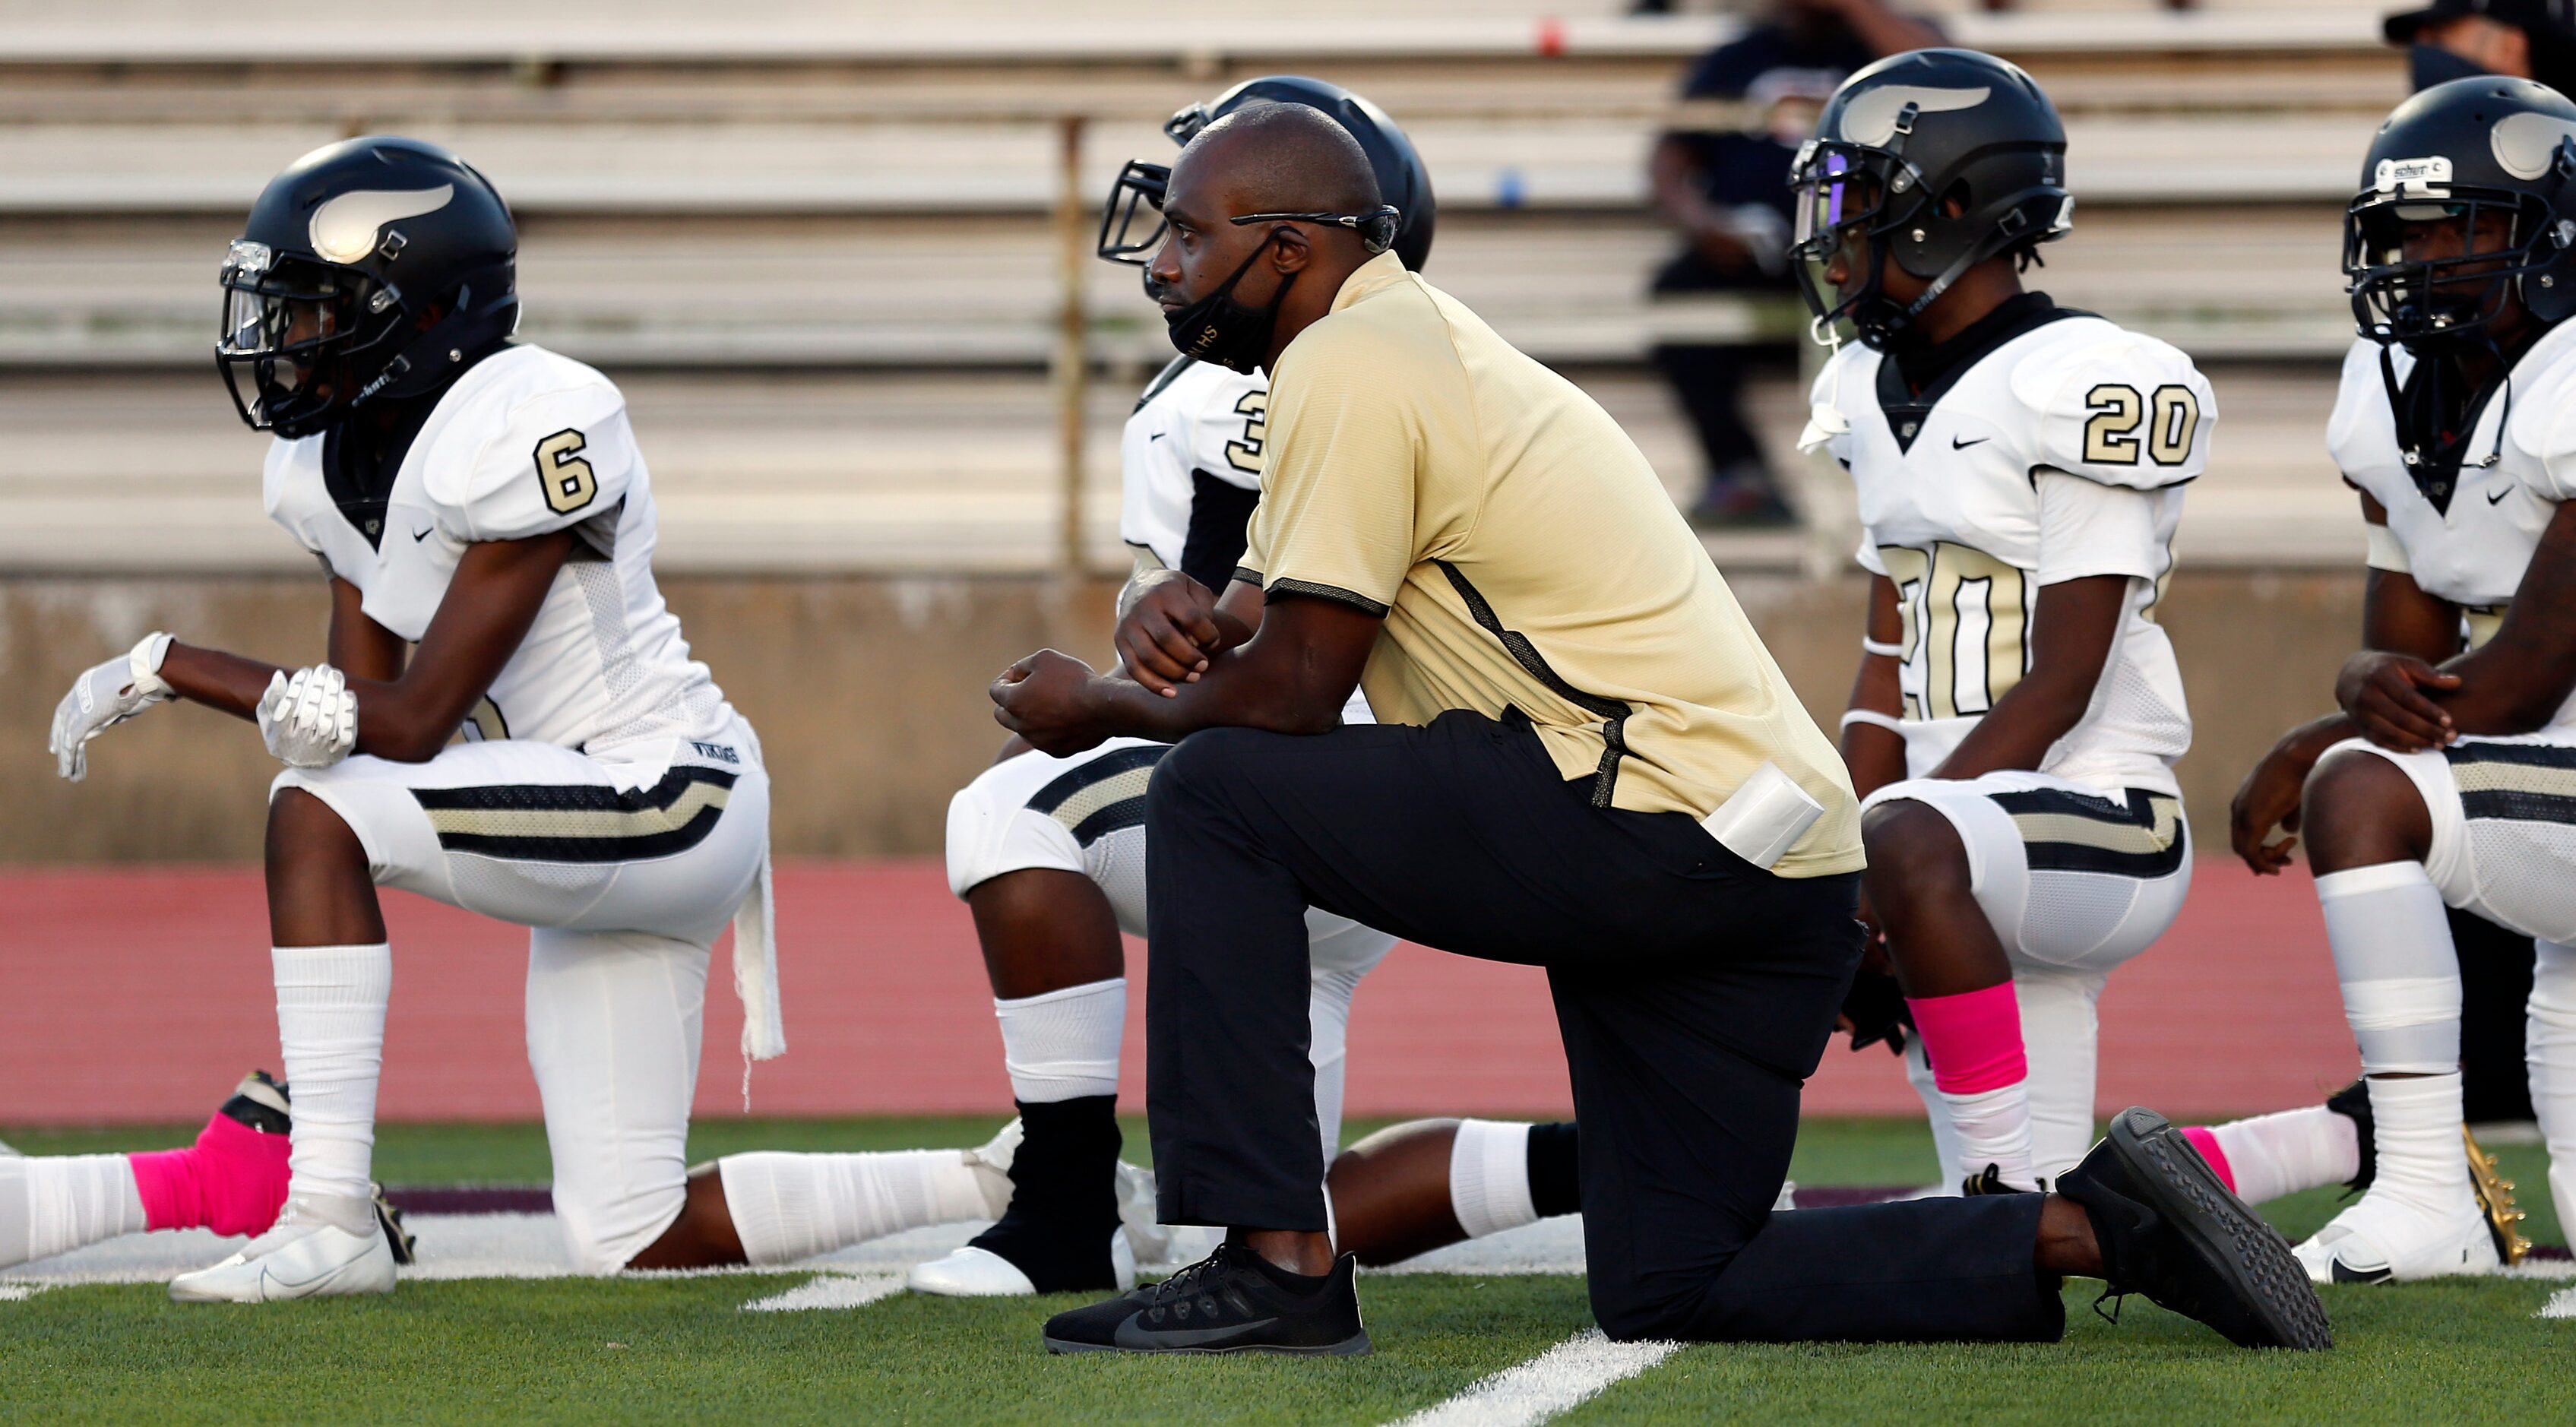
0 1071 291 1267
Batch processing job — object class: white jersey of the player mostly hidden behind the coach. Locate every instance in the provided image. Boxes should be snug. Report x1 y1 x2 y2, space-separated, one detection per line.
1118 358 1370 724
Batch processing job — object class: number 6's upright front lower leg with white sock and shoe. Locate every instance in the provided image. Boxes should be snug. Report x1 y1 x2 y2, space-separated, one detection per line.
170 783 394 1303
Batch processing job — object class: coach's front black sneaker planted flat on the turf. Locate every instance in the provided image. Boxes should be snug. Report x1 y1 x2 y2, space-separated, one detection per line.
1046 1244 1368 1357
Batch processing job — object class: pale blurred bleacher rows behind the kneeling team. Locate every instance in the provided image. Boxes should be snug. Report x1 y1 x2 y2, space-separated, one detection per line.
0 0 2404 572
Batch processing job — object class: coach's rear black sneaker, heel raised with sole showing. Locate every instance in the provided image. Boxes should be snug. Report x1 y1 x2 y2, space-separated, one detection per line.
2059 1108 2334 1349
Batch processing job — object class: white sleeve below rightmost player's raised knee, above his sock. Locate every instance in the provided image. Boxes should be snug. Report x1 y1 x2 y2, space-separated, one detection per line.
2316 863 2460 1066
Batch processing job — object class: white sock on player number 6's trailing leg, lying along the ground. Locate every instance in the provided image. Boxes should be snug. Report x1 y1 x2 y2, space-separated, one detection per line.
716 1149 1010 1264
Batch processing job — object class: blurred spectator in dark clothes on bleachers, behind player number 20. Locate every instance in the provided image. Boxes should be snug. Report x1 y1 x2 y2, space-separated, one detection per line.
1651 0 1942 526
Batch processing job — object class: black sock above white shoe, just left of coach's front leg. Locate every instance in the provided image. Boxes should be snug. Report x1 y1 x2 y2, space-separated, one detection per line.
973 1095 1121 1293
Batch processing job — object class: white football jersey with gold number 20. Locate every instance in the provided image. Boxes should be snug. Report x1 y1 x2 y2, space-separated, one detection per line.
1814 309 2218 793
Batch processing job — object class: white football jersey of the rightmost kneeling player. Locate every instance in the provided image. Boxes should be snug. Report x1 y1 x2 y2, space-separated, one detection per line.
2326 322 2576 695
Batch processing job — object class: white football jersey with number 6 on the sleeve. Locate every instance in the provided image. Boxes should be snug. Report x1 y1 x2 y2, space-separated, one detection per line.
265 345 732 780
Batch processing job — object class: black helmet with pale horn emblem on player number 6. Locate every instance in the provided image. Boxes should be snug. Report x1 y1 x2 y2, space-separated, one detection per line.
214 134 517 438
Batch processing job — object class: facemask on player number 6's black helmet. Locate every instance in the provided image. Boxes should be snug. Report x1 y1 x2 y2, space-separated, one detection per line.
214 242 399 438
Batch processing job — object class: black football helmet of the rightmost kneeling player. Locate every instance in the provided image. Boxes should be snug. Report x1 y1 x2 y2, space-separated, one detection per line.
2344 74 2576 350
